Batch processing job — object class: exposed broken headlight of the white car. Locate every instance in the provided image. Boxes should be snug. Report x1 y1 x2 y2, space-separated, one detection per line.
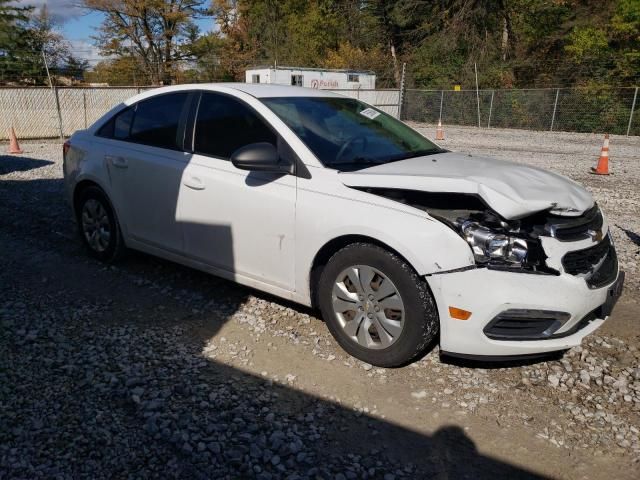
460 220 529 265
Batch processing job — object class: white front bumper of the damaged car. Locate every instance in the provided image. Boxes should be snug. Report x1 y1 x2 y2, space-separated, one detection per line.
427 268 624 358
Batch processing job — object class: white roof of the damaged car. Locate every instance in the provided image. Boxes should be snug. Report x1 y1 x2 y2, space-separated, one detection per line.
140 82 341 98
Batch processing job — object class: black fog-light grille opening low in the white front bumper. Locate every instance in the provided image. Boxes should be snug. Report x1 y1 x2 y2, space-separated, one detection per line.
484 309 571 340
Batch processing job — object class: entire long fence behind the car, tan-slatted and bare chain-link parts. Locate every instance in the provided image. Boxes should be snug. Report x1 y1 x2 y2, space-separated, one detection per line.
0 87 640 140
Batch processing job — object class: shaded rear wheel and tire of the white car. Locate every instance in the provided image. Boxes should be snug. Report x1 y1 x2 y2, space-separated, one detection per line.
76 186 126 263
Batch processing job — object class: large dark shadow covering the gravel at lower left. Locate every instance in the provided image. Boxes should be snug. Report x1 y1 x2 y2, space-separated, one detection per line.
0 164 543 480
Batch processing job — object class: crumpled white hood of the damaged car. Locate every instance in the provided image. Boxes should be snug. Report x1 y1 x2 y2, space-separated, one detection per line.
338 152 594 220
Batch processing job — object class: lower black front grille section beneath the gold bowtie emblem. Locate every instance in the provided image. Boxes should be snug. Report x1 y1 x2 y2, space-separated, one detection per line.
562 235 618 288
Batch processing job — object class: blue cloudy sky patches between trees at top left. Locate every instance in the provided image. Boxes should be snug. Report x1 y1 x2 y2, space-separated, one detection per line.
15 0 213 65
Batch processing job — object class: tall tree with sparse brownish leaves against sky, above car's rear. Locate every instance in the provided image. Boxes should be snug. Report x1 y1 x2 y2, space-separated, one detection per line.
83 0 205 84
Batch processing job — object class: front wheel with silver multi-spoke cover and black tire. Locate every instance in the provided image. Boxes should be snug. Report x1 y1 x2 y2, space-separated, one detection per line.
318 243 439 367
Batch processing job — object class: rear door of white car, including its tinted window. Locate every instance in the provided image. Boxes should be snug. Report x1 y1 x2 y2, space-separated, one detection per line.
105 92 193 252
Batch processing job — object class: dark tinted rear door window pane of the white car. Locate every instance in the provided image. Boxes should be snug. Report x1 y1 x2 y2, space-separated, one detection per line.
129 92 189 150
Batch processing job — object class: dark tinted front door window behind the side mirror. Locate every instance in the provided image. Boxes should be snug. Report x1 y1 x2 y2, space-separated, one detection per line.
193 92 278 160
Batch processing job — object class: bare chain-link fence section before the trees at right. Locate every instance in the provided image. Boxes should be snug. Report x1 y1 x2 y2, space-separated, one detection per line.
402 87 640 135
